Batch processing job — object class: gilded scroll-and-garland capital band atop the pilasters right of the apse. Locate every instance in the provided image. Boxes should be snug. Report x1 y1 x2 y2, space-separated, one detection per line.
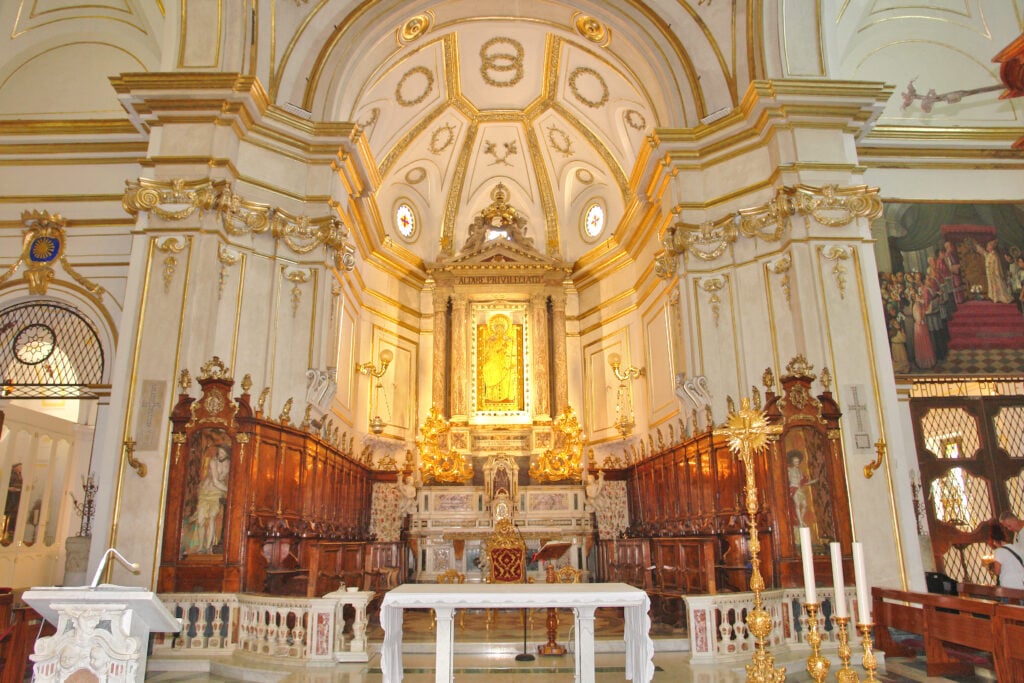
654 184 882 279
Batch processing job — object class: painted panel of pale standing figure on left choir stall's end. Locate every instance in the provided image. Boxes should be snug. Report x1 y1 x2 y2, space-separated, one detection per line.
181 429 231 557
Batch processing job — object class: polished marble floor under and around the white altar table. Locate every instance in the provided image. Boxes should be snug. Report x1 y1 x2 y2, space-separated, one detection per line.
145 610 994 683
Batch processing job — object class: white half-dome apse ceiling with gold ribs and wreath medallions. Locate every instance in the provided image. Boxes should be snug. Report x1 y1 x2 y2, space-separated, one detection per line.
288 2 753 270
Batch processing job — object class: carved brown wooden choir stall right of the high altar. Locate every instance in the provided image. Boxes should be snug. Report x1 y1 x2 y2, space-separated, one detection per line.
598 356 852 618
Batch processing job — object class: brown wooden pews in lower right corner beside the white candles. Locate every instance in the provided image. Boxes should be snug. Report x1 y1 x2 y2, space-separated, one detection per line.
871 588 1024 681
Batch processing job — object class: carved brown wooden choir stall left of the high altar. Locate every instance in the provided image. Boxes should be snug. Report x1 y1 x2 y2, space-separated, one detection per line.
158 356 385 597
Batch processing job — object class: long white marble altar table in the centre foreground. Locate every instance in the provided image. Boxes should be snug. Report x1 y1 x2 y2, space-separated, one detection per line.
381 584 654 683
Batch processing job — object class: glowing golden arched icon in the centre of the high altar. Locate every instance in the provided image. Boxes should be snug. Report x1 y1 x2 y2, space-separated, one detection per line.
476 313 525 412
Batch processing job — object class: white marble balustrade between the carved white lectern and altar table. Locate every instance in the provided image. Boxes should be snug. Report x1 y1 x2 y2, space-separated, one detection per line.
154 590 374 661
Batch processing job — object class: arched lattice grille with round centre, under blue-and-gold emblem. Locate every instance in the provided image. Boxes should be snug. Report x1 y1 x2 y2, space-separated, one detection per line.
0 301 103 398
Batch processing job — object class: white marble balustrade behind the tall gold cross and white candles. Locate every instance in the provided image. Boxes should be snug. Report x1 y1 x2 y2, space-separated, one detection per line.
683 588 856 661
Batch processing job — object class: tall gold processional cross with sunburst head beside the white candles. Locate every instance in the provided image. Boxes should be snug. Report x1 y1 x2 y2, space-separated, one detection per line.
715 397 785 683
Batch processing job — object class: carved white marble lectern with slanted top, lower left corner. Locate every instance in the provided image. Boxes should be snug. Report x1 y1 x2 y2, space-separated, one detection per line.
23 586 181 683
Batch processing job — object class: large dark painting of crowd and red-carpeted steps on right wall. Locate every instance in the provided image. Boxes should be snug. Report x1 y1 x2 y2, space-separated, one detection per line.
876 202 1024 375
